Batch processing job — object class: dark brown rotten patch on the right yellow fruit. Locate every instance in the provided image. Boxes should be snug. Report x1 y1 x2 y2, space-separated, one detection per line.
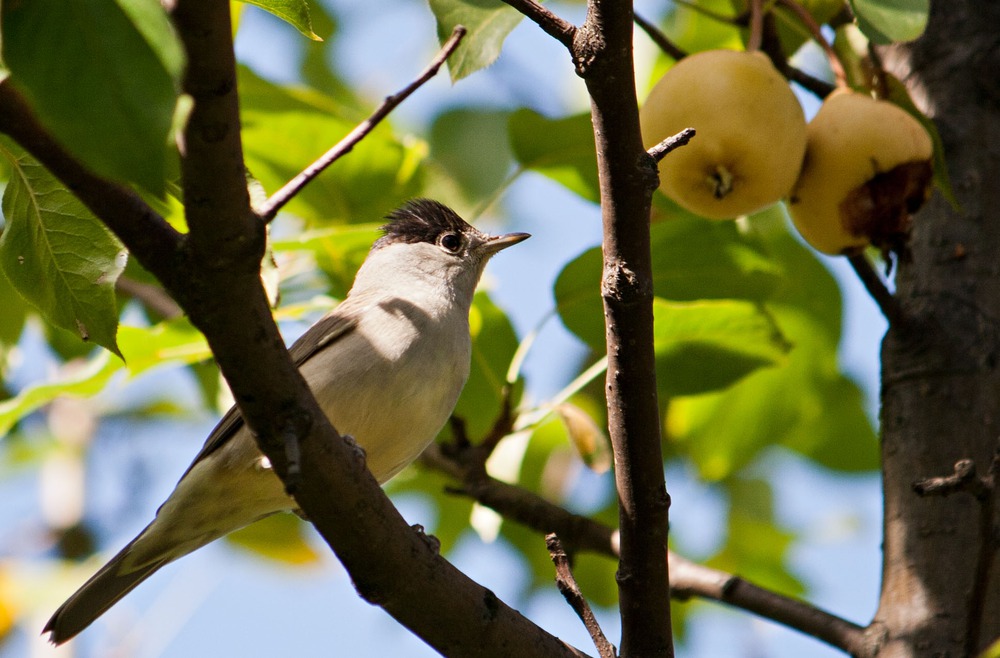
840 160 933 251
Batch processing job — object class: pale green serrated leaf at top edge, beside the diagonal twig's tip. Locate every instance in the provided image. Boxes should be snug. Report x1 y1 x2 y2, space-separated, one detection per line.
430 0 523 82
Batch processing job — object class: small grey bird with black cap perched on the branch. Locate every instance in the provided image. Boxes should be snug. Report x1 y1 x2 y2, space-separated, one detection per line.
42 199 530 644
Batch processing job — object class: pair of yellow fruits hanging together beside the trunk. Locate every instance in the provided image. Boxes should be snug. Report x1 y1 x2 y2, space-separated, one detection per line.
639 50 933 254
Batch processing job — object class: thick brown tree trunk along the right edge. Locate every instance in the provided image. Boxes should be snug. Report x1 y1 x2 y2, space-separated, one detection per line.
872 0 1000 657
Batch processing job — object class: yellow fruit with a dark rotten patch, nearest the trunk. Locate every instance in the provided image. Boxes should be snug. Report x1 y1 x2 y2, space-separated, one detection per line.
788 89 934 254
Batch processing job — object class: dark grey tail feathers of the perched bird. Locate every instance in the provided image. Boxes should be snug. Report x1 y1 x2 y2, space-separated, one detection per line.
42 520 169 644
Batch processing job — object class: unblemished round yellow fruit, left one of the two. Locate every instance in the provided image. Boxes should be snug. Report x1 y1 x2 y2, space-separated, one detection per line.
639 50 806 219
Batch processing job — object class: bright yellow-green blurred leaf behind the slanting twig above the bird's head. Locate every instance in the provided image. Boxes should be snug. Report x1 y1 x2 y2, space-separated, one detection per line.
239 68 426 224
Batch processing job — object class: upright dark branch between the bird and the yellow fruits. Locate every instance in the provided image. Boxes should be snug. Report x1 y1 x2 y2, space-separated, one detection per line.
573 0 673 657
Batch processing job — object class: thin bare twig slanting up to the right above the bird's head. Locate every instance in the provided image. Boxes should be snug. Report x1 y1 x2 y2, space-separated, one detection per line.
257 25 466 223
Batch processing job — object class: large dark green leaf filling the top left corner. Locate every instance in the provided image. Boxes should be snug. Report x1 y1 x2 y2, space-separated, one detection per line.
2 0 184 193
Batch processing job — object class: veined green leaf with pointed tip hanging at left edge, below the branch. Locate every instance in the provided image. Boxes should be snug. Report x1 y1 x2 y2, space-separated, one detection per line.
0 143 127 354
